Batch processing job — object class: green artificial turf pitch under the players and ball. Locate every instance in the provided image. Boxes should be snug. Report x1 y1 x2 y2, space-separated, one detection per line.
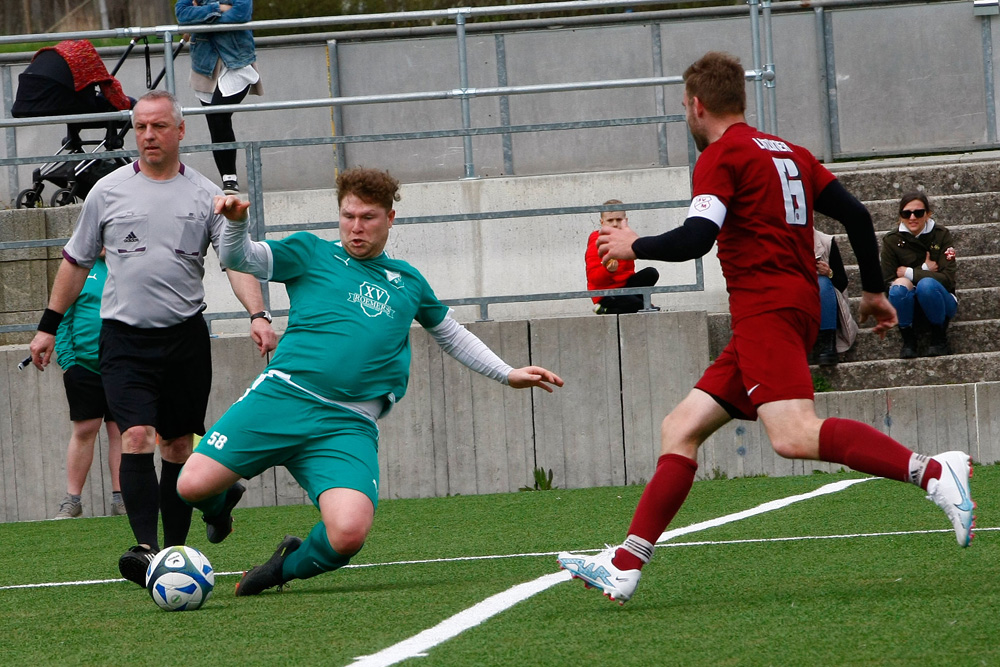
0 466 1000 667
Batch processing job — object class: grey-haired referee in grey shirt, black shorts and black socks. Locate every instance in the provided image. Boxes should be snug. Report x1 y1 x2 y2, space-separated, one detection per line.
31 90 277 586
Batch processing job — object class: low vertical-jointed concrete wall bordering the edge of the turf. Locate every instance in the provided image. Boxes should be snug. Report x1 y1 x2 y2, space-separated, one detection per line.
0 312 1000 521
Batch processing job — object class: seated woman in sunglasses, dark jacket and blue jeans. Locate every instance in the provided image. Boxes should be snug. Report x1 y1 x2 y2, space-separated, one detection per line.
882 191 958 359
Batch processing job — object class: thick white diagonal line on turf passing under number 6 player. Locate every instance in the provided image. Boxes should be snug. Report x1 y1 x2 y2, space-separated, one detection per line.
351 477 879 667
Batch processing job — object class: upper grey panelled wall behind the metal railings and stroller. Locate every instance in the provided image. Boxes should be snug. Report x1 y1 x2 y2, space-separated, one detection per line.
0 0 1000 201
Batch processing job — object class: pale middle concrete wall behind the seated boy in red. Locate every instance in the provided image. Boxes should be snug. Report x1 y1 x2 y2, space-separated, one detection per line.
0 167 727 344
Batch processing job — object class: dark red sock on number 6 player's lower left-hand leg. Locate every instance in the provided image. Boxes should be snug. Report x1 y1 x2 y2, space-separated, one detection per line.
612 454 698 570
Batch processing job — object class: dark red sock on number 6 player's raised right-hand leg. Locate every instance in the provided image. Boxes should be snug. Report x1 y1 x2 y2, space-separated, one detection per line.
819 417 916 482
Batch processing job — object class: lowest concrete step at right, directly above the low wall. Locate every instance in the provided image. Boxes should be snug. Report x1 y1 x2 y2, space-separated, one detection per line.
813 352 1000 391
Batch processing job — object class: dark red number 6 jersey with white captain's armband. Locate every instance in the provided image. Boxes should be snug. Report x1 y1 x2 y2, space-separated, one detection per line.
688 123 835 323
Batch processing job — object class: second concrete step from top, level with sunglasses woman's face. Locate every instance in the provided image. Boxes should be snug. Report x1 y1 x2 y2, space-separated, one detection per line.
814 192 1000 234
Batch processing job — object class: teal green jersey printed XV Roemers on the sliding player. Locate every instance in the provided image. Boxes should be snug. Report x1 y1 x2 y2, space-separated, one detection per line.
265 232 448 402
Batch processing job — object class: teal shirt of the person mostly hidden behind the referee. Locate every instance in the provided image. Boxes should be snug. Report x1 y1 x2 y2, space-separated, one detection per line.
56 257 108 374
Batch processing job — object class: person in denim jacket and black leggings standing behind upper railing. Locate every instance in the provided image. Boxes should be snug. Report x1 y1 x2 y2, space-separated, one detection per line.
174 0 264 195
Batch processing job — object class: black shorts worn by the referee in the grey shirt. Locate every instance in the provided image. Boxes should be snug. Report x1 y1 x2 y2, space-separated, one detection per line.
101 314 212 440
